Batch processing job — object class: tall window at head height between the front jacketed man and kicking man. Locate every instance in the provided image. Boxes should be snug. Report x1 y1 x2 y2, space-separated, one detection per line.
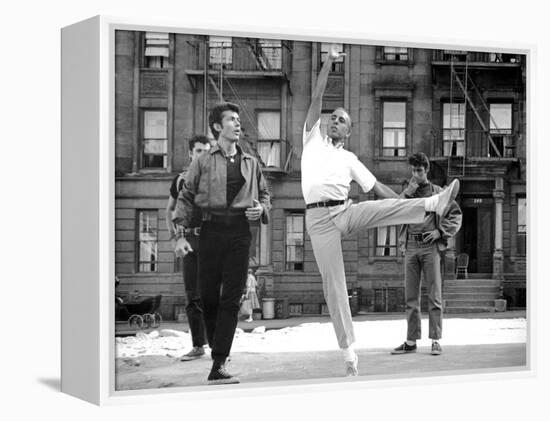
257 111 281 168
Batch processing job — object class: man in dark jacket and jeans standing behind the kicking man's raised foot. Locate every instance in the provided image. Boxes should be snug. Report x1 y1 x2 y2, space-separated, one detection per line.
391 152 462 355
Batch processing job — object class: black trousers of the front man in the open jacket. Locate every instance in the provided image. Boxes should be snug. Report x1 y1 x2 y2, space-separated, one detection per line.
199 216 252 362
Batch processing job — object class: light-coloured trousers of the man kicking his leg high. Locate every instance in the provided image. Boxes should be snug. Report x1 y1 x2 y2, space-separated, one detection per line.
306 199 426 349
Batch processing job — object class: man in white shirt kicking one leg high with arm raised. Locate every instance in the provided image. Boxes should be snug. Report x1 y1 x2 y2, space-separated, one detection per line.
302 45 459 376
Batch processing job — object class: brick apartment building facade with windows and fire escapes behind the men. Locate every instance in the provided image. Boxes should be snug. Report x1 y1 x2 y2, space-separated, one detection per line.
115 31 527 318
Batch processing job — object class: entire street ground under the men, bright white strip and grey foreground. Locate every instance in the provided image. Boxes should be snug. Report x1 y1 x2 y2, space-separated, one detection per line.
115 311 527 390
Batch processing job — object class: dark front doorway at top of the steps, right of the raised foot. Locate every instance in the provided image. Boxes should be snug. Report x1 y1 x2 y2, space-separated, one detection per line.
457 198 494 273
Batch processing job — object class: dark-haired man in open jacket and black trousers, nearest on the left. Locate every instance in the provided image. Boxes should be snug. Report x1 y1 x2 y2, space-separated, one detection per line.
174 102 271 384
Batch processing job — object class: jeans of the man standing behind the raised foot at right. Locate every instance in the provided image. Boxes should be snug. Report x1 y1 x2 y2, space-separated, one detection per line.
405 240 443 340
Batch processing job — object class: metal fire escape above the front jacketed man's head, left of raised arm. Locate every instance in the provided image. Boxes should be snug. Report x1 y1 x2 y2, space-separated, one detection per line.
186 37 294 175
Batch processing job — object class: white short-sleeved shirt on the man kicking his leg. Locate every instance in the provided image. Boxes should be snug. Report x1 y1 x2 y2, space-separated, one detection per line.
302 120 376 204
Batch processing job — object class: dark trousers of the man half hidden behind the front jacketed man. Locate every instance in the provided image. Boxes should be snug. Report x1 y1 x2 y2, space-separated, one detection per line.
183 236 206 347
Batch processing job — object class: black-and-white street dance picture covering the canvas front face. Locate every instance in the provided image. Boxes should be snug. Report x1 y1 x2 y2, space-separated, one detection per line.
112 27 529 391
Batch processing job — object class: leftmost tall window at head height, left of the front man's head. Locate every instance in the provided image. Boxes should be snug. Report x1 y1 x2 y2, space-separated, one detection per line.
142 111 168 168
